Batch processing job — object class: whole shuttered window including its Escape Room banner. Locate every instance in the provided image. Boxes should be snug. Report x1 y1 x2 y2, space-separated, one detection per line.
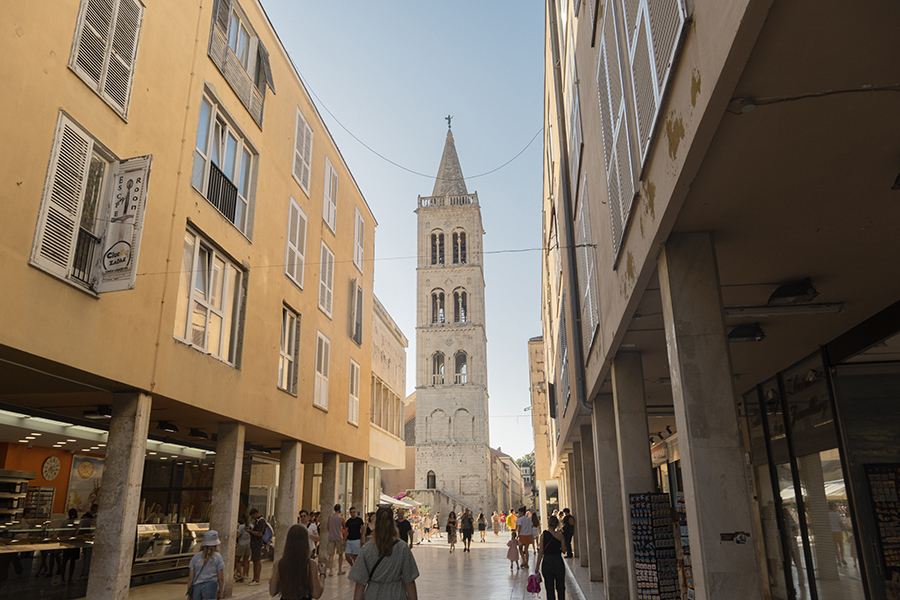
30 112 152 293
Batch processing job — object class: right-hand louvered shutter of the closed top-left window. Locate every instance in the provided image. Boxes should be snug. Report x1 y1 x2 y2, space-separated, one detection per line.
103 0 144 114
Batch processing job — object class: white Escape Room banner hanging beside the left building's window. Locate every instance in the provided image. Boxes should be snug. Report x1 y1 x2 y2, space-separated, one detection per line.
94 155 153 294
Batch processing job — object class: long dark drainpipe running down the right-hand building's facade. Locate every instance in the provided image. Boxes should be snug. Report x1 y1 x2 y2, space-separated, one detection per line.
547 0 593 414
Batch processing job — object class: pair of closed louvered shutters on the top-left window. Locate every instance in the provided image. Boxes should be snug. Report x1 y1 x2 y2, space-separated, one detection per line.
69 0 144 117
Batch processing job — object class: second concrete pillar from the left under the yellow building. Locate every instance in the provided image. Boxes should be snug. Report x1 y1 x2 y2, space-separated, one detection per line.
209 423 246 598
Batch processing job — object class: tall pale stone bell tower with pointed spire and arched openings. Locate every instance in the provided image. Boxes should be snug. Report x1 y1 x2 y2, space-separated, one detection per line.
415 124 494 515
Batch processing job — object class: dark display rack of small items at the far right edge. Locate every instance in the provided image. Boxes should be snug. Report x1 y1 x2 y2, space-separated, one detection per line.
865 464 900 600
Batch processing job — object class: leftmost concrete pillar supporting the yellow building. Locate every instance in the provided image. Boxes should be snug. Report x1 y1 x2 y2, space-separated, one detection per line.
85 393 151 600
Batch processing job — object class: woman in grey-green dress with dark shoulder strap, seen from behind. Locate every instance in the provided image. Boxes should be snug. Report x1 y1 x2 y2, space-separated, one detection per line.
350 507 419 600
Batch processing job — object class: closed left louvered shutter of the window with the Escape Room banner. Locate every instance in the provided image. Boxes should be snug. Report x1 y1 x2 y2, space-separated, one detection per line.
31 117 93 277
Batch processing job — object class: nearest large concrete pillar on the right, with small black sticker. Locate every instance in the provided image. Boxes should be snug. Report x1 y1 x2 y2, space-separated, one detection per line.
658 233 763 600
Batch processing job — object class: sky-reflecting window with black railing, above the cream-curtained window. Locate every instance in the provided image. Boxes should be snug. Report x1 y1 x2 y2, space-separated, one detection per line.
191 95 257 237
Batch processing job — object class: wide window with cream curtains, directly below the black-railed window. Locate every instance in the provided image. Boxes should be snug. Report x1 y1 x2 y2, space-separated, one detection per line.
175 230 244 363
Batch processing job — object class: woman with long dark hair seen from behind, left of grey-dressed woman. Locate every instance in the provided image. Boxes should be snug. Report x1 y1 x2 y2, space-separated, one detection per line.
269 523 325 600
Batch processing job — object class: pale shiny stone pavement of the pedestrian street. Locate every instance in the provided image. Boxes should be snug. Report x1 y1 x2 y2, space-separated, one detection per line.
86 531 603 600
